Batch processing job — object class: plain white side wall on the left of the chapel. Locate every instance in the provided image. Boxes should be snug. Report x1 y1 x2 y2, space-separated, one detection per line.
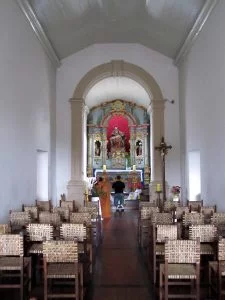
0 0 56 222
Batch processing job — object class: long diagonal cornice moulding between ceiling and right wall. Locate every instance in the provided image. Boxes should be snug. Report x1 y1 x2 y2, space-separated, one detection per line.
174 0 220 66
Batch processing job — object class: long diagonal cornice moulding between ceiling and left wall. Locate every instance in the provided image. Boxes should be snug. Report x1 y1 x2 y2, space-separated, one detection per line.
17 0 61 68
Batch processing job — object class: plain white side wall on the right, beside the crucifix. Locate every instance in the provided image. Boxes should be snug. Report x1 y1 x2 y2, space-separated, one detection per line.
179 1 225 211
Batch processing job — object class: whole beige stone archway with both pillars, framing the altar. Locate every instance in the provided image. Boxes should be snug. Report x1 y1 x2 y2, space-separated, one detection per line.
68 60 164 202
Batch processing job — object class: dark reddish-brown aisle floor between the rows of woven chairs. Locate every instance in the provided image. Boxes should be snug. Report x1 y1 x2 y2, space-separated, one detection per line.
93 210 152 300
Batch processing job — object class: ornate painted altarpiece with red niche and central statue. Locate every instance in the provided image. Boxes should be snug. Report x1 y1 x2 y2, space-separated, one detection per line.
87 100 150 183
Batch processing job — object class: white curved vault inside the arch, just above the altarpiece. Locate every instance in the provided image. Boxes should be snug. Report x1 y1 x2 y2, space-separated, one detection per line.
85 76 150 108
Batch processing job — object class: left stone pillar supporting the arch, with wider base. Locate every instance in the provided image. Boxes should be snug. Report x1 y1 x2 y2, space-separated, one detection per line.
67 98 87 206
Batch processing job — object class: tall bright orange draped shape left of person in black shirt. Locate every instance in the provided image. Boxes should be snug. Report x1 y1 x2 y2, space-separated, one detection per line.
95 175 111 219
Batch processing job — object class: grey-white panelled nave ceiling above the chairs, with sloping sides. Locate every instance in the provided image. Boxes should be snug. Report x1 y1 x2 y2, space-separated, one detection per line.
17 0 217 65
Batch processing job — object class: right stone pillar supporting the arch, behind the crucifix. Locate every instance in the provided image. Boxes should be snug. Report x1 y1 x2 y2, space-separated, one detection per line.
148 100 165 199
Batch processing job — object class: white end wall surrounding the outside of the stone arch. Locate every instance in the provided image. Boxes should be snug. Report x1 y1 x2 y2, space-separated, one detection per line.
56 44 180 195
